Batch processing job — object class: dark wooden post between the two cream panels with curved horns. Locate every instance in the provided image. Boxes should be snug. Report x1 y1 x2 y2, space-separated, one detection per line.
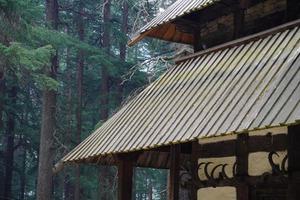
236 134 249 200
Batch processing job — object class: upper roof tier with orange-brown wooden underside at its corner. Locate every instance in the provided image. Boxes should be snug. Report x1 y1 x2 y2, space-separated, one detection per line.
129 0 220 46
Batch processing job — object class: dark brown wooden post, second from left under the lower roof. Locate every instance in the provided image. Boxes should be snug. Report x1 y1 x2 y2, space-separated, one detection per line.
168 145 181 200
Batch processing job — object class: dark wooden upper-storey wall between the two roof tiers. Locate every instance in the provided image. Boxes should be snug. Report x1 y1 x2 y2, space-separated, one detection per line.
174 0 300 51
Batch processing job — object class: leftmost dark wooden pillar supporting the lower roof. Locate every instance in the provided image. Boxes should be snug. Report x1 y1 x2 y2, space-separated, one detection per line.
117 154 137 200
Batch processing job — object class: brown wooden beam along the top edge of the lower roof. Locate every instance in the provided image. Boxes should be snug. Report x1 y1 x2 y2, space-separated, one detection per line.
174 19 300 64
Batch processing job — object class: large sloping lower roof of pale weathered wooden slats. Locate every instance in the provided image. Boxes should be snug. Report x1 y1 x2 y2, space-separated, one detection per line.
63 22 300 162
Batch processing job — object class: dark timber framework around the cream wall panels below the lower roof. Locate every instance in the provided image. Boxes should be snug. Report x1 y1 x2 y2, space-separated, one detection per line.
110 125 300 200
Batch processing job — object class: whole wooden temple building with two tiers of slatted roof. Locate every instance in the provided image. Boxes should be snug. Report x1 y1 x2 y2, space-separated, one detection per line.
60 0 300 200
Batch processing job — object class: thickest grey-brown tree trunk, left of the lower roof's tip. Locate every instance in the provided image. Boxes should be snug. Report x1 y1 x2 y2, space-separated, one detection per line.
37 0 58 200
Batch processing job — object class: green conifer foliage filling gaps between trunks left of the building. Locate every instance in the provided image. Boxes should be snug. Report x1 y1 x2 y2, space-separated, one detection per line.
0 0 175 200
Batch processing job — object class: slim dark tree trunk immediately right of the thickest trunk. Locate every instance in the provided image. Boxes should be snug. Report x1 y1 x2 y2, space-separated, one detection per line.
74 0 84 200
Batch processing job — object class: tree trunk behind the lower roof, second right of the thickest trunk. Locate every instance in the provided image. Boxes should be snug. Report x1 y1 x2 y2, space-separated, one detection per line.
98 0 112 200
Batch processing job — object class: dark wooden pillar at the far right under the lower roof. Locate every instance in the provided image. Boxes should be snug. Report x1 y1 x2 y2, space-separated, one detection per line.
287 125 300 200
